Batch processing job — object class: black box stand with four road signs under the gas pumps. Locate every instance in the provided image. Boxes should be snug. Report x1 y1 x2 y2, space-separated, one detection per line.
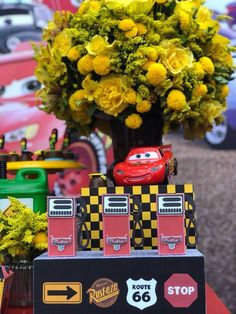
34 249 206 314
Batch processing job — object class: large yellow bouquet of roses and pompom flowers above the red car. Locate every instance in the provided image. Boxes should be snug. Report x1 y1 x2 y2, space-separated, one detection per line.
35 0 234 137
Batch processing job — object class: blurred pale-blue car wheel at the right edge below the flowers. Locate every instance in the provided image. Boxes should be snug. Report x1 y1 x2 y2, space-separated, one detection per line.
205 118 236 149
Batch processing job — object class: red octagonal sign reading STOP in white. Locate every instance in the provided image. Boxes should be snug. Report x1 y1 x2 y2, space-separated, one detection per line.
164 274 198 307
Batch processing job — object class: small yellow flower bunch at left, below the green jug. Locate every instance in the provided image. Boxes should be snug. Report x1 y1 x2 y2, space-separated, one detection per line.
0 197 47 262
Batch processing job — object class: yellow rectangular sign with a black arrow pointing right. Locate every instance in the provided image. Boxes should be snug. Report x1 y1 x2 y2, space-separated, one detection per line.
43 282 82 304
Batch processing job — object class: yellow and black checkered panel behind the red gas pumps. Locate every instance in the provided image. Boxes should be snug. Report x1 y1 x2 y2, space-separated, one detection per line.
81 184 197 250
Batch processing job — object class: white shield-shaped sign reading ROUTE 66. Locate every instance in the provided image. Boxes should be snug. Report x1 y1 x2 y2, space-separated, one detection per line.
126 278 157 310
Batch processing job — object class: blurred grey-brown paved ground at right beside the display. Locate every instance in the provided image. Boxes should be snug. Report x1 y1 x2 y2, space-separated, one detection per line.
164 135 236 314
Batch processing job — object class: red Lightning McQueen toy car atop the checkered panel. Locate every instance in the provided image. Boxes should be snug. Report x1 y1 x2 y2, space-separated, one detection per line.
113 145 177 185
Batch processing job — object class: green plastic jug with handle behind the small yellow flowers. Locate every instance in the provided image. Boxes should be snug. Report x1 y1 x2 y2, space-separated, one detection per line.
0 168 49 213
